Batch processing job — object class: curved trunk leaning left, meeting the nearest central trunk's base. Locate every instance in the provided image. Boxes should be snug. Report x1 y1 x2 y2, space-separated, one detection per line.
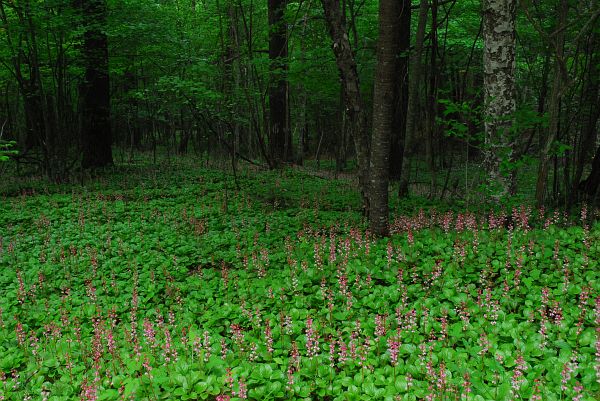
321 0 369 214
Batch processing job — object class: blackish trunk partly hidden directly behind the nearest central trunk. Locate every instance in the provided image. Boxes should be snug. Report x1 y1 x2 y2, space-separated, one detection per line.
390 0 411 180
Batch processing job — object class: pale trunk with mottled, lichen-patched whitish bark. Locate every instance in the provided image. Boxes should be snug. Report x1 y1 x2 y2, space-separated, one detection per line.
483 0 516 202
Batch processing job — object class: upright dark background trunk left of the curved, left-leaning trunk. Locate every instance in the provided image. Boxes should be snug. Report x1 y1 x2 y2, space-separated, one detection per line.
269 0 292 166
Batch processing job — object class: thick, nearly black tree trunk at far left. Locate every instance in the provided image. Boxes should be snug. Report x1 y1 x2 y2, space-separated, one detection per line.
81 0 113 168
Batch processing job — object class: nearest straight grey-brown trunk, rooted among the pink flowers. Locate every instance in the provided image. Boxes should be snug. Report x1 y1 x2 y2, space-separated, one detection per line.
369 0 401 236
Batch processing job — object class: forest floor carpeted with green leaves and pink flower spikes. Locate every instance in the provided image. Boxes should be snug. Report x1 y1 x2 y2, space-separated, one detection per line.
0 161 600 401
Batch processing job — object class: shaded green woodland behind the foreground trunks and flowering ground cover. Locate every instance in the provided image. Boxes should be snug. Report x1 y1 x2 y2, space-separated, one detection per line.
0 0 600 217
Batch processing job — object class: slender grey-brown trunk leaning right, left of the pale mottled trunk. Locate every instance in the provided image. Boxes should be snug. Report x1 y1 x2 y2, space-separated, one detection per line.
398 0 429 197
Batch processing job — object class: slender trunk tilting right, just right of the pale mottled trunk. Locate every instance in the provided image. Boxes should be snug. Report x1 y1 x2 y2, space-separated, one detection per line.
535 0 569 207
